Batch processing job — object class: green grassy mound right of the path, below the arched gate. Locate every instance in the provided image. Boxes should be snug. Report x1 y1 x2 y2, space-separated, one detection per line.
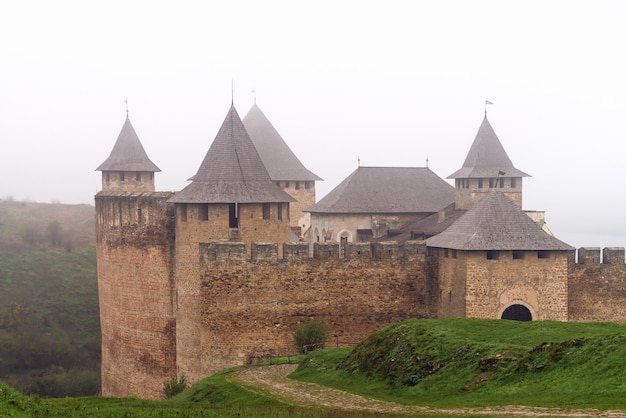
294 319 626 409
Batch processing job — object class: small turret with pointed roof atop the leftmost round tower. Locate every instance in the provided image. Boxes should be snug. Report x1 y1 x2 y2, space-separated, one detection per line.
96 113 161 192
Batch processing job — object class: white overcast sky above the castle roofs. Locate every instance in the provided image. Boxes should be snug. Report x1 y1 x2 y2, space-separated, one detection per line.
0 0 626 247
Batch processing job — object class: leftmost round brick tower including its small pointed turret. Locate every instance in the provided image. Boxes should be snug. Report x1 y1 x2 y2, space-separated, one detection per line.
95 117 176 398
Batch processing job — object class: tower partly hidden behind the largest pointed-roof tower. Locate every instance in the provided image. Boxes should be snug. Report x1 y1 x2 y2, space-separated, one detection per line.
243 103 322 236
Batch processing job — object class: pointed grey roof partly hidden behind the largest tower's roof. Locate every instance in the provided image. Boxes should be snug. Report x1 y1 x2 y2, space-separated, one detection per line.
243 103 321 181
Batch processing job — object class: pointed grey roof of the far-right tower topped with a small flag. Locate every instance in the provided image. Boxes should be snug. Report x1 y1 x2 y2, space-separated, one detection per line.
448 114 529 179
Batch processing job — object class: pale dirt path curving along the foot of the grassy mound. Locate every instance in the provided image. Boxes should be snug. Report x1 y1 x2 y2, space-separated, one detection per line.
228 364 626 417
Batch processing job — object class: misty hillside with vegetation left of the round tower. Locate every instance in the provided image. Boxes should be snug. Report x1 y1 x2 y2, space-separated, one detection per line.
0 200 100 396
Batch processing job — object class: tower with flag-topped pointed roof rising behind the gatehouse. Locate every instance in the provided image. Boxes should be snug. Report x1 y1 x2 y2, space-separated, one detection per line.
448 113 529 209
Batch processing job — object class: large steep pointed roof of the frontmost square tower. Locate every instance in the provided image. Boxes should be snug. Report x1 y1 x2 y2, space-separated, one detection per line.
169 106 294 203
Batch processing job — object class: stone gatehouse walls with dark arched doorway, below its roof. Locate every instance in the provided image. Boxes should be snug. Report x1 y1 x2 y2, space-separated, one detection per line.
438 249 569 321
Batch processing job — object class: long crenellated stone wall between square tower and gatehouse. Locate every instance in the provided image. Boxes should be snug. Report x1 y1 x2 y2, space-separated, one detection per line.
196 242 434 376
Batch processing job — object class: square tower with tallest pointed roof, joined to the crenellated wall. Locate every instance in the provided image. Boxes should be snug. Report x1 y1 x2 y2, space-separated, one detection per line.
169 106 294 382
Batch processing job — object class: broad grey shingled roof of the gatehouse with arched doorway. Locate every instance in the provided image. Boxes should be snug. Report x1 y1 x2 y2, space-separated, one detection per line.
426 189 574 251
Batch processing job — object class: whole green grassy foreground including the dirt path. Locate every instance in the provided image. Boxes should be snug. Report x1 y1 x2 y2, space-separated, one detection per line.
0 319 626 418
